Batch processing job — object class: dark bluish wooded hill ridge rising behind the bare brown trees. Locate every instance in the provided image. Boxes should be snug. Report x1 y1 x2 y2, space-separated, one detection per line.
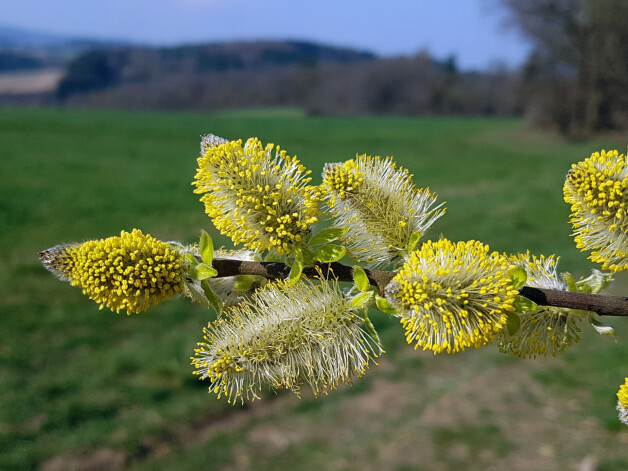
58 41 376 98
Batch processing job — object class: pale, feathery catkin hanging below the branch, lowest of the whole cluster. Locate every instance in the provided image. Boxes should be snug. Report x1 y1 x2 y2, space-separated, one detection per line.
192 281 381 402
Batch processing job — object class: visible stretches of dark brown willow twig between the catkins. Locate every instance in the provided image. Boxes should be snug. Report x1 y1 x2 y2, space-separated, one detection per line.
212 258 628 317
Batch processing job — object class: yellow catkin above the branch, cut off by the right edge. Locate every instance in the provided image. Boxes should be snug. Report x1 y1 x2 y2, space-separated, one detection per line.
563 150 628 272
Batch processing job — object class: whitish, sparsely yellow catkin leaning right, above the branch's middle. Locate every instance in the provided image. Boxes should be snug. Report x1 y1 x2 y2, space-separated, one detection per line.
321 155 445 265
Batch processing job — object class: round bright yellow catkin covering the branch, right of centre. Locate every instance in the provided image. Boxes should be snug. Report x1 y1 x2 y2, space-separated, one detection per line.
386 239 518 353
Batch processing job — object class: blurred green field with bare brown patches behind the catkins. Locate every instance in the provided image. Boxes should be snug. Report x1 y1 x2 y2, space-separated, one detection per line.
0 109 628 471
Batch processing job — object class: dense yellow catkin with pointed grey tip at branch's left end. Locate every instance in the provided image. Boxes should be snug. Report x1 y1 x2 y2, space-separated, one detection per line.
41 229 183 314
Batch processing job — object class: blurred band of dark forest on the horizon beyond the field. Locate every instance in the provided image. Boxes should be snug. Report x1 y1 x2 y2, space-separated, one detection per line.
56 41 522 115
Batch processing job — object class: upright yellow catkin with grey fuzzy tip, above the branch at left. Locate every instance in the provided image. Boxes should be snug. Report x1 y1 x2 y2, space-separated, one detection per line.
193 138 320 254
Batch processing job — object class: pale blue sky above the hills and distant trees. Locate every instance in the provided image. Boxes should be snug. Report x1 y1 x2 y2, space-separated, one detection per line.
0 0 529 69
